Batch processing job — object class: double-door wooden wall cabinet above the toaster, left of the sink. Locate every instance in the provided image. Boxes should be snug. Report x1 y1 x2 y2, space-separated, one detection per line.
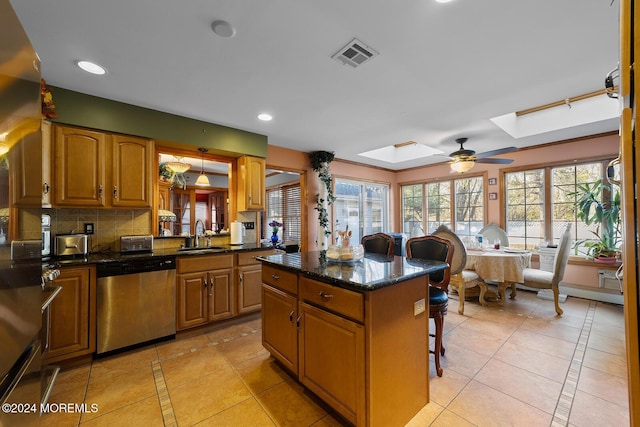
52 126 153 208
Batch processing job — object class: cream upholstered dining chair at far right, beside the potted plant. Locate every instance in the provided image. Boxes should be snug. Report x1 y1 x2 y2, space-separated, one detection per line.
523 224 571 316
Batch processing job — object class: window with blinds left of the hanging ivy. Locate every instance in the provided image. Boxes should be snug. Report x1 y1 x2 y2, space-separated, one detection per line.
262 184 301 243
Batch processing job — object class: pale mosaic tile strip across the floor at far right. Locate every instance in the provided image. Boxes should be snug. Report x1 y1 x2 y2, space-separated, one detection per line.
551 301 596 427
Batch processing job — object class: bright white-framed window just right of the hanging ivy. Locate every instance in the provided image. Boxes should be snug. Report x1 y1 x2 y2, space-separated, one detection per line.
332 178 389 244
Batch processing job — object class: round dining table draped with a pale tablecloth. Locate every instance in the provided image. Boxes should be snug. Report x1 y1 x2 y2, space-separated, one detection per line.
465 247 531 305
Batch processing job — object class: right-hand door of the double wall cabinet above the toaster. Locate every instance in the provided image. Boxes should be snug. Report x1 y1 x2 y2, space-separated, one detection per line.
110 135 154 208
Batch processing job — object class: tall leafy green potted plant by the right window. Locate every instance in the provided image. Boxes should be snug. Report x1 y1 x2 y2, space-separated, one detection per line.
573 179 622 263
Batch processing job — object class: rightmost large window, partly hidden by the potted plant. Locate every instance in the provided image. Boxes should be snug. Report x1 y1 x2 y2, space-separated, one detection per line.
504 160 609 253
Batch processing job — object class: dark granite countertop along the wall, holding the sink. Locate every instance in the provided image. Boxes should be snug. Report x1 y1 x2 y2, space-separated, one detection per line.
43 243 269 266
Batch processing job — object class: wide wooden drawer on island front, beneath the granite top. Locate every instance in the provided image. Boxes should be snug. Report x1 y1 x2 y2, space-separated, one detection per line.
300 277 364 322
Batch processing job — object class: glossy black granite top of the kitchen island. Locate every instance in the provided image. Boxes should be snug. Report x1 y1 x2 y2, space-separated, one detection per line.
258 252 449 291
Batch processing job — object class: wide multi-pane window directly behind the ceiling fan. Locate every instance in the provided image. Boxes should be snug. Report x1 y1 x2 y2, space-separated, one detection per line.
401 176 484 238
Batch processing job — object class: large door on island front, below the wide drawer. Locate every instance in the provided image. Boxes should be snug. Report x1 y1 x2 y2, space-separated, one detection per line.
298 302 365 425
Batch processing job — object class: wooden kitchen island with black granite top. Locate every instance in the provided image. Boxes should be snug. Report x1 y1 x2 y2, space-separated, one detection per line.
259 252 448 426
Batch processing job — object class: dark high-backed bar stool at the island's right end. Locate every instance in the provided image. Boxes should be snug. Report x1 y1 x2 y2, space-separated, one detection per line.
406 235 455 377
